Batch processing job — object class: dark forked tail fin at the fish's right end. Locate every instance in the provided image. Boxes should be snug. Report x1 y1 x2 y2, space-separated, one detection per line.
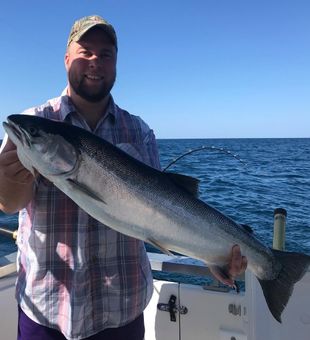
258 249 310 323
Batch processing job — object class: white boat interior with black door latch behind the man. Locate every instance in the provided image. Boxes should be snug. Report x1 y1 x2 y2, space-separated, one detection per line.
0 247 310 340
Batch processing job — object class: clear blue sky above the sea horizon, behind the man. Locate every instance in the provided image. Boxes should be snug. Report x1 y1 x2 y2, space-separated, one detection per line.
0 0 310 138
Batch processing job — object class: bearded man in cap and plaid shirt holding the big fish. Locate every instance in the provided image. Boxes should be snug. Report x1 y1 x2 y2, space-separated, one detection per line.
0 16 246 340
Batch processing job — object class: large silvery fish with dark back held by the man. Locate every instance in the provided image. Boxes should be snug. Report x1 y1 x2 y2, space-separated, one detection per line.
3 114 310 322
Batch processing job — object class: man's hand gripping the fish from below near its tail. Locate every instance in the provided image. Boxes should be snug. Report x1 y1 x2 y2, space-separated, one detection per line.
210 245 248 287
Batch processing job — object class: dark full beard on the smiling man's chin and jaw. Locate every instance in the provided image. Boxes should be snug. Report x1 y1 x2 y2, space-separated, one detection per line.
68 70 116 103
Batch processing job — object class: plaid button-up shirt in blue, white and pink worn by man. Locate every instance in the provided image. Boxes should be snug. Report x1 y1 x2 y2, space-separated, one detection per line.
16 93 160 339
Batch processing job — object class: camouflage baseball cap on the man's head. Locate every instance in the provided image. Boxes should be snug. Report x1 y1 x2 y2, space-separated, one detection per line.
67 15 117 48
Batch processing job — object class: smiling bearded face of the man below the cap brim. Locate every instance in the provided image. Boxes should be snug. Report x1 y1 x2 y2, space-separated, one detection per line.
65 27 117 103
